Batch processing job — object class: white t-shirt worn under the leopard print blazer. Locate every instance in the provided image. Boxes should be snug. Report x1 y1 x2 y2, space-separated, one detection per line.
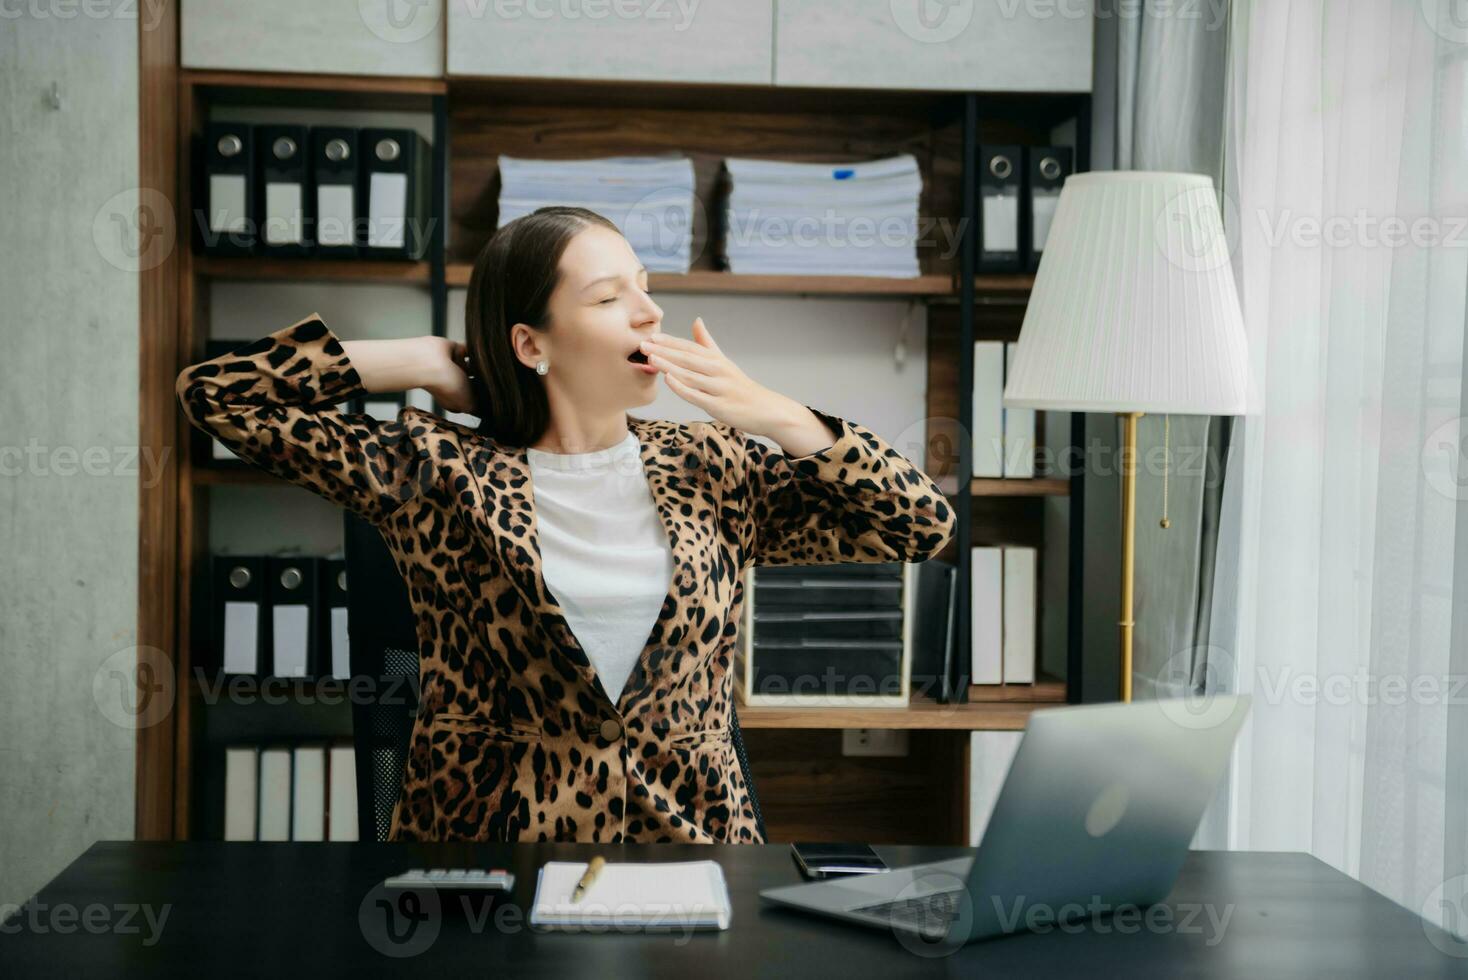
526 431 672 701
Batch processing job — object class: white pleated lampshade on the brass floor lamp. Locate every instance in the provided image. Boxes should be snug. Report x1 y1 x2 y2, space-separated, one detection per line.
1004 170 1248 415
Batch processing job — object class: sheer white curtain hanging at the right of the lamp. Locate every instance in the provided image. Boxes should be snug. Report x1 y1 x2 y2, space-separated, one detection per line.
1210 0 1468 933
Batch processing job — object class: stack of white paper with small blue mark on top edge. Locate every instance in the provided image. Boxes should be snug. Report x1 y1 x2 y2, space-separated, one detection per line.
724 153 922 277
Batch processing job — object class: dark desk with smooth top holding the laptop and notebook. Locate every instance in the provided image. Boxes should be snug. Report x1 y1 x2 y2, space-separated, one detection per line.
0 842 1468 980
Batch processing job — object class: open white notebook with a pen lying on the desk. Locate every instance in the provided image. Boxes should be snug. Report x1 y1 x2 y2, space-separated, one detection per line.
530 861 730 932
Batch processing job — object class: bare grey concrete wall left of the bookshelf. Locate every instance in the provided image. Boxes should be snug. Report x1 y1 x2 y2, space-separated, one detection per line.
0 11 147 914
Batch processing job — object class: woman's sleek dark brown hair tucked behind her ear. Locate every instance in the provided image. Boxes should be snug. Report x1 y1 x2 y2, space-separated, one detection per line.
464 205 619 446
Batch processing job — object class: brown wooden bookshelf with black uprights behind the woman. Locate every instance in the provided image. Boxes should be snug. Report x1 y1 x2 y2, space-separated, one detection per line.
138 65 1089 844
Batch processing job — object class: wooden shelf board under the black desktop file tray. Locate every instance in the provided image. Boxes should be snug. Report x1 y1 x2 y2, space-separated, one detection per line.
738 697 1054 732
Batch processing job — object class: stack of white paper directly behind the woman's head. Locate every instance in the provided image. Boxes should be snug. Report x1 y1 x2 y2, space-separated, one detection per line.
499 156 693 273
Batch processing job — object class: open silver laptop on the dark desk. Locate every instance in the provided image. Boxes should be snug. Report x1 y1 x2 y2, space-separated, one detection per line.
759 694 1251 951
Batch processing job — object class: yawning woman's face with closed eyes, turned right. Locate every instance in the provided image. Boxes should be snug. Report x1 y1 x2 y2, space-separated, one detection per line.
515 224 662 412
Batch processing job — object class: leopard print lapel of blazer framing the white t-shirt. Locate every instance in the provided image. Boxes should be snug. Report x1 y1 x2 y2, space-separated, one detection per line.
467 418 697 710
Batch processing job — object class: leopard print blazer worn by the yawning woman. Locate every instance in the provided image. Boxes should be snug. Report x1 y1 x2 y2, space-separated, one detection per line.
176 314 954 844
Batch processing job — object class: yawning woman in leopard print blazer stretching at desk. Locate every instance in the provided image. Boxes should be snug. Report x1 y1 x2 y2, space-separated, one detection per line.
178 207 954 842
